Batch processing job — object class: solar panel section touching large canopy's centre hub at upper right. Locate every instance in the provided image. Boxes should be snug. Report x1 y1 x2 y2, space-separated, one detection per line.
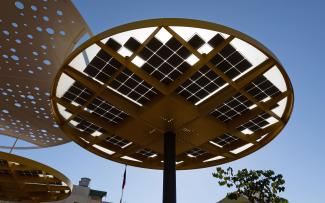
176 66 226 104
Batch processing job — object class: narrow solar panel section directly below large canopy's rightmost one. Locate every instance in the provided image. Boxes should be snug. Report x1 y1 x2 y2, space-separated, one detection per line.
237 113 271 132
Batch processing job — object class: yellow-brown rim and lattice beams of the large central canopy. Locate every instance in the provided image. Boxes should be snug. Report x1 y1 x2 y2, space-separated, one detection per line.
51 19 294 170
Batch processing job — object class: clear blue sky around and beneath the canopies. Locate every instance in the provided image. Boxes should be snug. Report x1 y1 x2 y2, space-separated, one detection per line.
0 0 325 203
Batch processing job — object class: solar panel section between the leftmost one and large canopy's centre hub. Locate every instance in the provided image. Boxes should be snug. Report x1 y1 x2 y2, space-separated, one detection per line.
87 97 128 124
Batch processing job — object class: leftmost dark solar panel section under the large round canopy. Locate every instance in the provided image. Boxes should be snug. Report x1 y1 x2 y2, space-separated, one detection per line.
62 82 93 105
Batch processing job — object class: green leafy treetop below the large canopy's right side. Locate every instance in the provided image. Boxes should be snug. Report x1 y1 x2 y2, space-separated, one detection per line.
212 167 288 203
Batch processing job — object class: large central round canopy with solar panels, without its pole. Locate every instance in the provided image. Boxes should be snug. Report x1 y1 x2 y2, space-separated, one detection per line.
51 19 293 169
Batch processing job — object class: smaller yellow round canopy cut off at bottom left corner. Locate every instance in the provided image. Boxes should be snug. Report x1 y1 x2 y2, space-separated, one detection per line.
0 152 72 202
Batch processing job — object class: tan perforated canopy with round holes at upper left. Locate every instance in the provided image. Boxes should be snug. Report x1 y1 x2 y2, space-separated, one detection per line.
0 0 90 147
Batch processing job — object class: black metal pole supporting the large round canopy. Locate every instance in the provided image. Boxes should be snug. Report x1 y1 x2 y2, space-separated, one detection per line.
163 131 176 203
